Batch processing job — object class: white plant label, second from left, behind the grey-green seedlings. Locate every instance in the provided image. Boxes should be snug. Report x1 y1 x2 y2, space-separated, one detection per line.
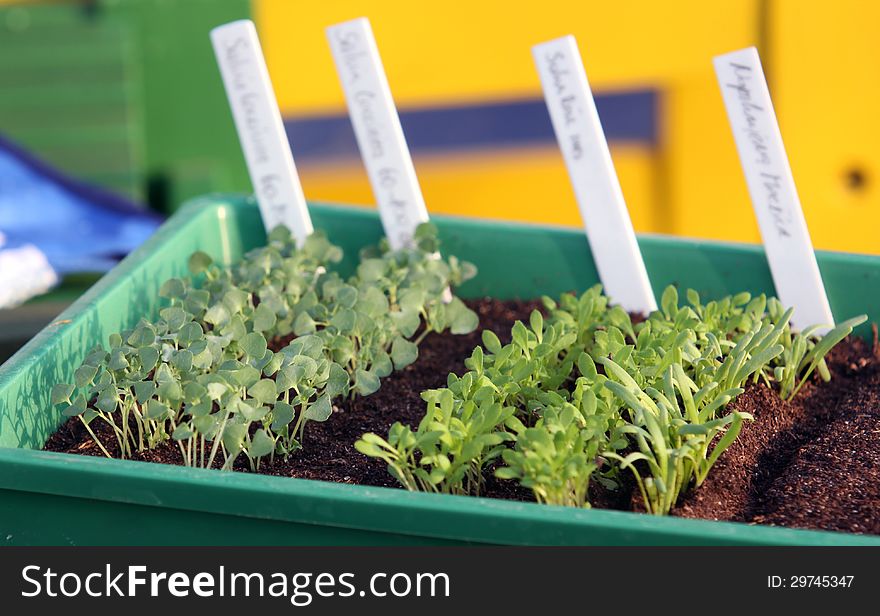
327 17 428 250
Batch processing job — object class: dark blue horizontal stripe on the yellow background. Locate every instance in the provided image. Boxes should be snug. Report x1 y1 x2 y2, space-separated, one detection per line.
284 90 659 158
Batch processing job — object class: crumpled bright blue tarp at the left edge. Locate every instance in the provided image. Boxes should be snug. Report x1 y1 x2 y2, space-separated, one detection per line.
0 136 161 274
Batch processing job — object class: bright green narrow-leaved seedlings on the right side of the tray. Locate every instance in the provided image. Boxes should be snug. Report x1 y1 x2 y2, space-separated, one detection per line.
356 286 865 514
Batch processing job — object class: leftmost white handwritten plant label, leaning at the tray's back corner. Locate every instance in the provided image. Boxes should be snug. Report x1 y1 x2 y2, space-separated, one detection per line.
211 19 313 245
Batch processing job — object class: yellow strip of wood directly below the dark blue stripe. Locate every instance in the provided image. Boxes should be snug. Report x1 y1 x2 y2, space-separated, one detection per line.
299 146 656 231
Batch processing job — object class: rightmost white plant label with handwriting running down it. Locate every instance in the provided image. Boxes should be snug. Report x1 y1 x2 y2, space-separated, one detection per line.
714 47 834 331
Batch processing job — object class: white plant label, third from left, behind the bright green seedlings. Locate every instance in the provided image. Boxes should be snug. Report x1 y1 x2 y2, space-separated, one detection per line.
532 36 657 314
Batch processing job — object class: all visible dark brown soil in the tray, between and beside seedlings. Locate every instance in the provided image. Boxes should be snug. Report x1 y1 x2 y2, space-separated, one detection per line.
45 299 880 534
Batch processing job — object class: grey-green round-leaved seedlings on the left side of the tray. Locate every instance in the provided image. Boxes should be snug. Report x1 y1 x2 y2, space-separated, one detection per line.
52 224 477 470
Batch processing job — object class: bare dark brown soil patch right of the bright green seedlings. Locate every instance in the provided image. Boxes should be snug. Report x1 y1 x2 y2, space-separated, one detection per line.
674 332 880 534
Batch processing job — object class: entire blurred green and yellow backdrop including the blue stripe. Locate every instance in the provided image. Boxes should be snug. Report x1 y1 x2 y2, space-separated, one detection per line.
0 0 880 253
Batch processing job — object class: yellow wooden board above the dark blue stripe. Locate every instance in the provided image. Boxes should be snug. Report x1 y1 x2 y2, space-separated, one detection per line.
254 0 758 114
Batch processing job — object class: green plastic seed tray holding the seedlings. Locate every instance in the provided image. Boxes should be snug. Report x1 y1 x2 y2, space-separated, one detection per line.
0 197 880 545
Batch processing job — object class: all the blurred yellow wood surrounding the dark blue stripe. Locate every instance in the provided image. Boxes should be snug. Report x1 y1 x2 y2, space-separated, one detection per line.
253 0 880 253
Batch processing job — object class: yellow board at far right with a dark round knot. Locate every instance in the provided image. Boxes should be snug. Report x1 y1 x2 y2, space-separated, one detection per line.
767 0 880 253
